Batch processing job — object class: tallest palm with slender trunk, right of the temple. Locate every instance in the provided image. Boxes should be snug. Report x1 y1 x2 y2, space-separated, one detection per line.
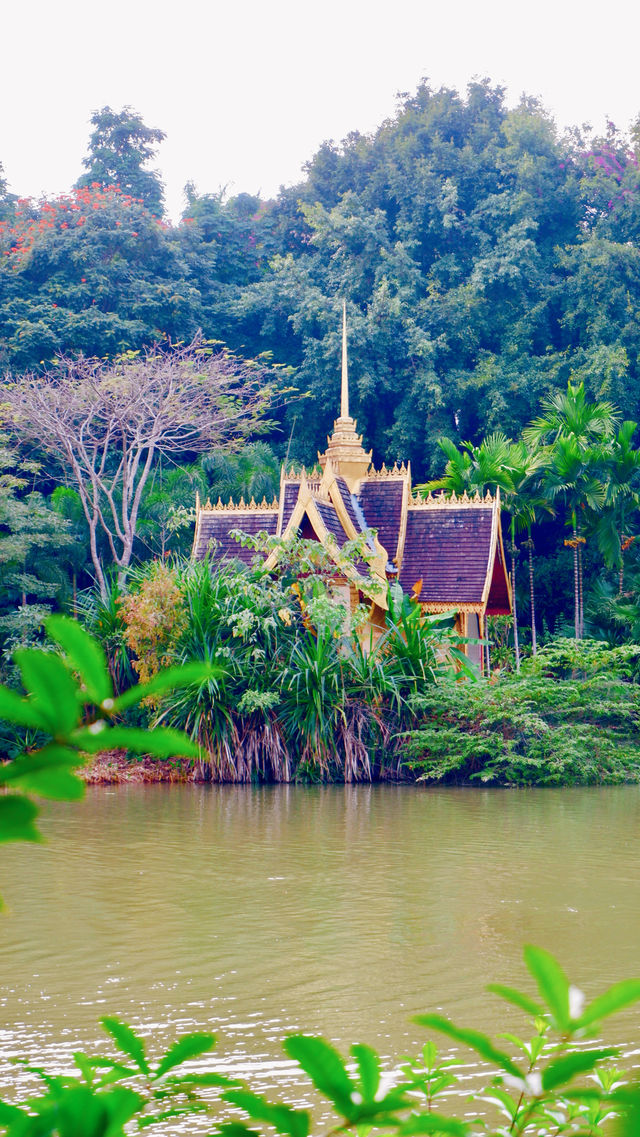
523 380 620 639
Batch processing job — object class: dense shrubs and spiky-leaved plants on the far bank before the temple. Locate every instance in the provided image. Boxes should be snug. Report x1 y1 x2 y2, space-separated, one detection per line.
47 552 640 786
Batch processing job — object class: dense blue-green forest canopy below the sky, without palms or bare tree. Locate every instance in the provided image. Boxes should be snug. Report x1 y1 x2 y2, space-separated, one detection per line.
0 80 640 645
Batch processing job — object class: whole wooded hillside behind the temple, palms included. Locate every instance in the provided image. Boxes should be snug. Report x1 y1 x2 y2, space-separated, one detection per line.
0 86 640 782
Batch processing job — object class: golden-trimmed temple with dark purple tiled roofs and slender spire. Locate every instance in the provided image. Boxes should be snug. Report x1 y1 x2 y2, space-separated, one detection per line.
193 306 512 665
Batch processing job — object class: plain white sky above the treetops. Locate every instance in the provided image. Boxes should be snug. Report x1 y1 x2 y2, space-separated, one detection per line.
0 0 640 218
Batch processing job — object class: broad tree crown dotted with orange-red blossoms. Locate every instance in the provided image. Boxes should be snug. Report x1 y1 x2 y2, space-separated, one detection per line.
0 183 201 368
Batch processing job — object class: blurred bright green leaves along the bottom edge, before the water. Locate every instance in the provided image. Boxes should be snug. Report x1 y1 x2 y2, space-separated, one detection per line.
0 946 640 1137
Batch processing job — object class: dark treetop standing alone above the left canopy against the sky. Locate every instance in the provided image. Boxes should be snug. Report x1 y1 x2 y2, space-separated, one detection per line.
75 107 166 216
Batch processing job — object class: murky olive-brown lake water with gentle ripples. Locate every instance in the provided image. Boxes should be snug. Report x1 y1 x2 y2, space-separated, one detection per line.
0 786 640 1134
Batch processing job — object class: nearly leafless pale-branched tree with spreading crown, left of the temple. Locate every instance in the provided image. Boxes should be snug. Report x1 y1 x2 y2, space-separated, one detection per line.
0 339 273 598
